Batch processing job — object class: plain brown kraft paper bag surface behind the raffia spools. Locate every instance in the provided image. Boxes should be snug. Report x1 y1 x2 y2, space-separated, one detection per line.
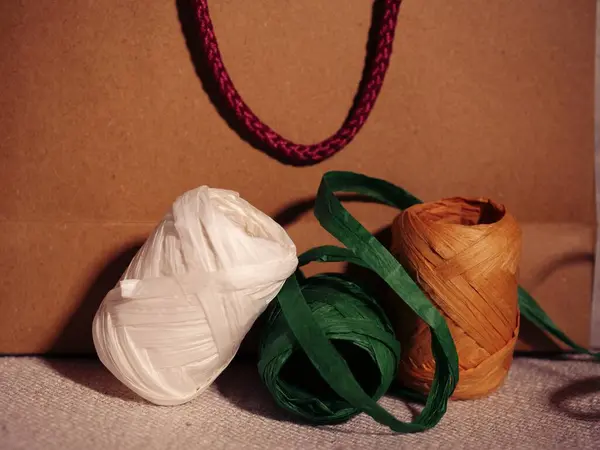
0 0 595 353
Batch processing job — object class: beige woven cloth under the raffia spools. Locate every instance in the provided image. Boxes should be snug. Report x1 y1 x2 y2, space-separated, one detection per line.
0 357 600 450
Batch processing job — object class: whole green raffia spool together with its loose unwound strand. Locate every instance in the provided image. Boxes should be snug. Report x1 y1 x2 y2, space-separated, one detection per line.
258 172 600 433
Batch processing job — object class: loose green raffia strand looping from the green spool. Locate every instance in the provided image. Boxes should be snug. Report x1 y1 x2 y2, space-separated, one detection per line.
259 171 600 433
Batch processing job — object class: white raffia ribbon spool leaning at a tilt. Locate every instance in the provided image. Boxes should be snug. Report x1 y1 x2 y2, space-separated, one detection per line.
92 186 298 405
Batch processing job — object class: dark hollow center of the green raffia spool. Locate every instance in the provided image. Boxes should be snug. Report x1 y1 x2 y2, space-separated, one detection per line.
279 339 381 410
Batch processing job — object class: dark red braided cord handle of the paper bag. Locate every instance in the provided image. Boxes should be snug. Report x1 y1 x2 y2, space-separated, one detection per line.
195 0 402 164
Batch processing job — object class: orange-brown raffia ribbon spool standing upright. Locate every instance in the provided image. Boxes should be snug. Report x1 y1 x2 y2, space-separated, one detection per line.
392 197 521 399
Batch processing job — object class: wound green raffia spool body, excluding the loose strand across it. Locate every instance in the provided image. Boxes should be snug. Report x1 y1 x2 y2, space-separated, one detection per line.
260 274 400 424
